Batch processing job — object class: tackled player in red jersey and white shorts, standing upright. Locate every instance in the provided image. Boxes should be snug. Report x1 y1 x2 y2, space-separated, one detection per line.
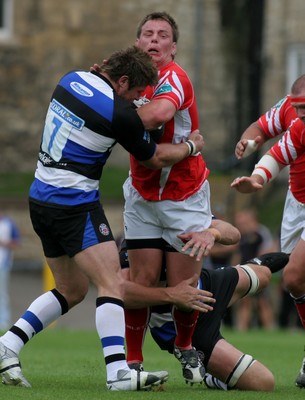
124 12 212 383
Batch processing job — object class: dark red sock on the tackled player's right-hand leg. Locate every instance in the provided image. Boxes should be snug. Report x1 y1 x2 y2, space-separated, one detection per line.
173 307 199 349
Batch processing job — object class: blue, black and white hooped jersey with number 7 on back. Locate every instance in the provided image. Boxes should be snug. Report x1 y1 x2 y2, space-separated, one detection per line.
29 71 155 206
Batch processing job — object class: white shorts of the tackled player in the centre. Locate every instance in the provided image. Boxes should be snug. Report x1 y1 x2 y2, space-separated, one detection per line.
123 177 212 253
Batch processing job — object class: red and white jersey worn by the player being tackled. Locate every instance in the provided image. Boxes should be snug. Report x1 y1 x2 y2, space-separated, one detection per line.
130 61 209 201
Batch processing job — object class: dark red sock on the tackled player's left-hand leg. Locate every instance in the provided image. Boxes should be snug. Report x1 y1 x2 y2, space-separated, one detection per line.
125 308 149 363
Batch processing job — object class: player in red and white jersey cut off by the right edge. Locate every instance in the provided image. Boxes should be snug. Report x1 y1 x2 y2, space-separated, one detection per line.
232 75 305 388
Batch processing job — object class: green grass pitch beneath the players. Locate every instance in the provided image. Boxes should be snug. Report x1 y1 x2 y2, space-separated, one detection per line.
0 328 304 400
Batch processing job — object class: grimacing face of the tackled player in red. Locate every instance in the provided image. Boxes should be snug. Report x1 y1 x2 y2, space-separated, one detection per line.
136 19 176 68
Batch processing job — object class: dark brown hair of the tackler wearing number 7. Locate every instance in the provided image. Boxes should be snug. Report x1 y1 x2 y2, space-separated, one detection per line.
101 46 158 89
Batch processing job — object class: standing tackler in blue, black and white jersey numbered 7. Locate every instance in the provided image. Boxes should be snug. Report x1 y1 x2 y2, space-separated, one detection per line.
0 46 203 390
